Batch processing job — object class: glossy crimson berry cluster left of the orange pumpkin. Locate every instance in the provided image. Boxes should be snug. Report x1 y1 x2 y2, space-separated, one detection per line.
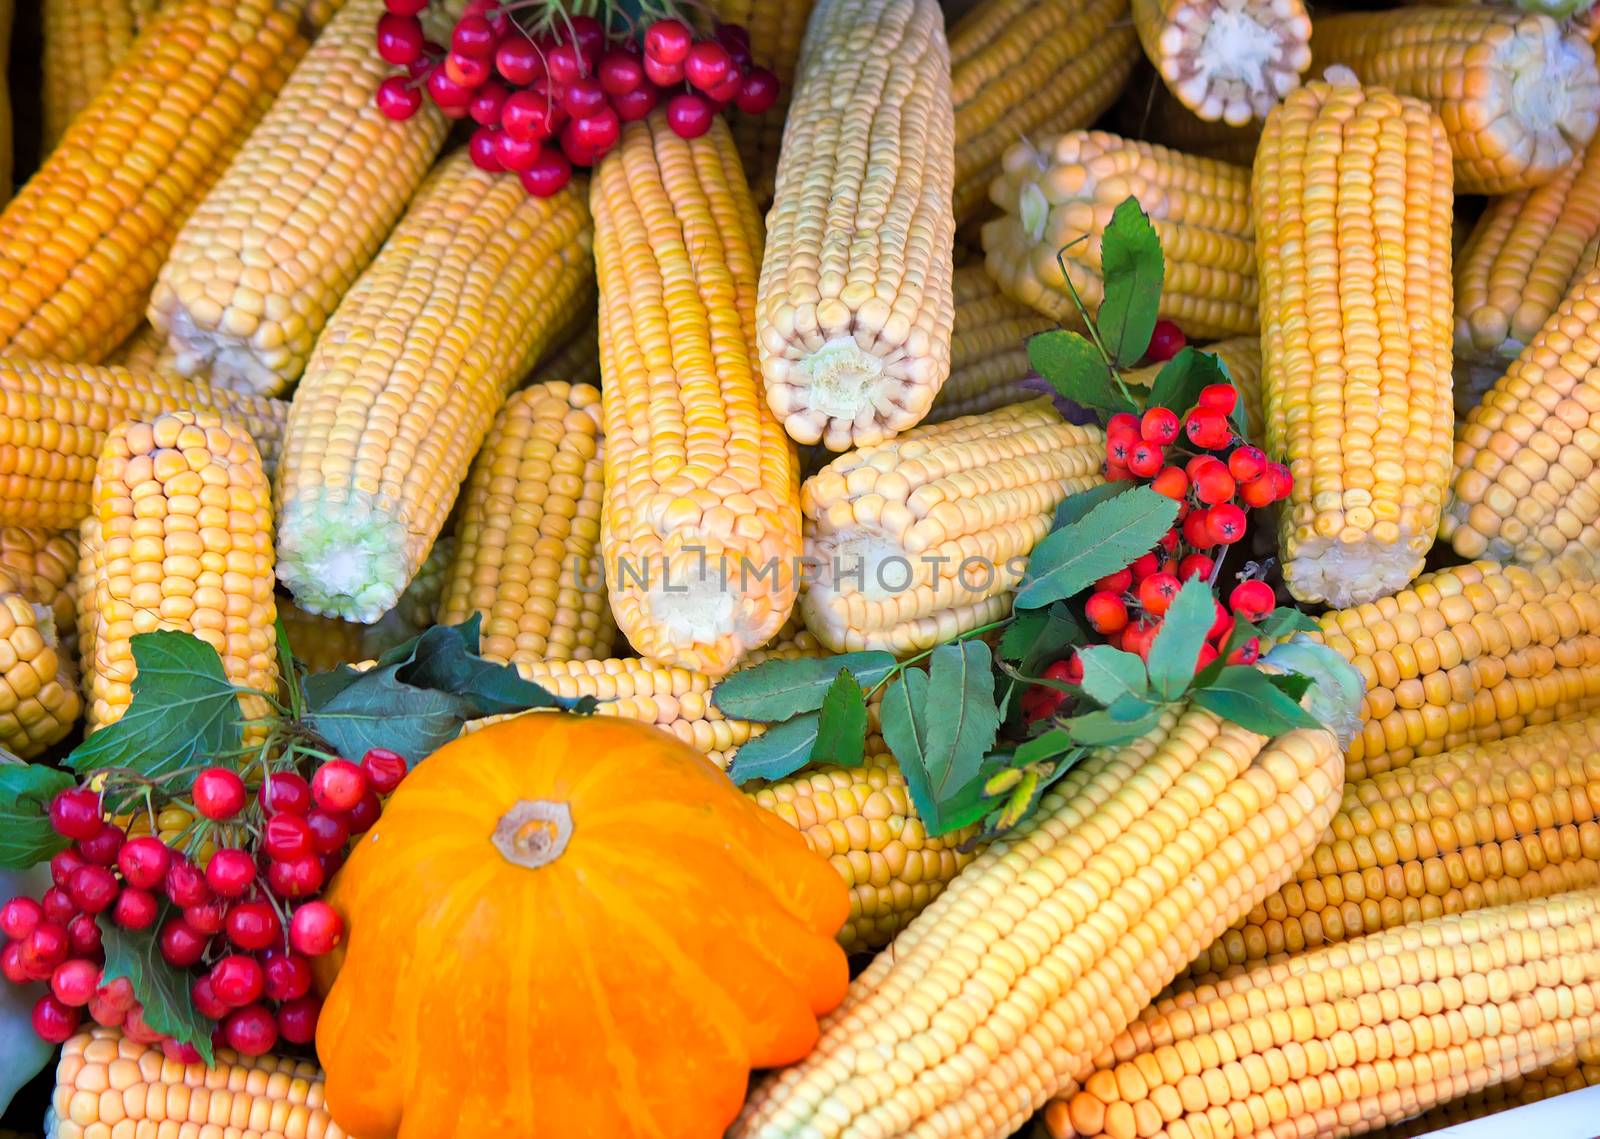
0 749 406 1064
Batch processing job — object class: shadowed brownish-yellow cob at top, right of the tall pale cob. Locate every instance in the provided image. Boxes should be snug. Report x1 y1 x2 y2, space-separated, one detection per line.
950 0 1139 222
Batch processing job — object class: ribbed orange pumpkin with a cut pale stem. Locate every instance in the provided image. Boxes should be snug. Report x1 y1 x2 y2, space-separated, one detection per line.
317 712 850 1139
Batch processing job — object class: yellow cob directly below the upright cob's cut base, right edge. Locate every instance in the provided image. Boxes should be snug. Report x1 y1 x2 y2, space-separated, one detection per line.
1315 562 1600 779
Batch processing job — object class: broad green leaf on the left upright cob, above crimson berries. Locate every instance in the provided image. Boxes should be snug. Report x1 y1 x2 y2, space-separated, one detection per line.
67 630 242 799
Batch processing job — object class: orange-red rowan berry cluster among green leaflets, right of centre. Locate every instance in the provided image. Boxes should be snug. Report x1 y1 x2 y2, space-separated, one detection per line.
1022 366 1293 721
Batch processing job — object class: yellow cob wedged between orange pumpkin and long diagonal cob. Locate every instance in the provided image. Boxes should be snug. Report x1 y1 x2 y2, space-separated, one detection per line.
749 737 978 953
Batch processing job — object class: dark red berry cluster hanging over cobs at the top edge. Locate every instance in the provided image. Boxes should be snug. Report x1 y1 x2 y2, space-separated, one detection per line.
378 0 778 197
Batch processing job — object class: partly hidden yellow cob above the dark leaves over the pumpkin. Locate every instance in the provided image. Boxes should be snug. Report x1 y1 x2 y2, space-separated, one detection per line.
438 381 616 661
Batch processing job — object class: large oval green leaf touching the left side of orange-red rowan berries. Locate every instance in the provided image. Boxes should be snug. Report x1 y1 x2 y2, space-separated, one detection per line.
1014 486 1178 609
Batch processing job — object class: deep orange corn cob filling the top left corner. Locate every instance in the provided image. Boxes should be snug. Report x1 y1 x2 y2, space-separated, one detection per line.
0 0 306 363
